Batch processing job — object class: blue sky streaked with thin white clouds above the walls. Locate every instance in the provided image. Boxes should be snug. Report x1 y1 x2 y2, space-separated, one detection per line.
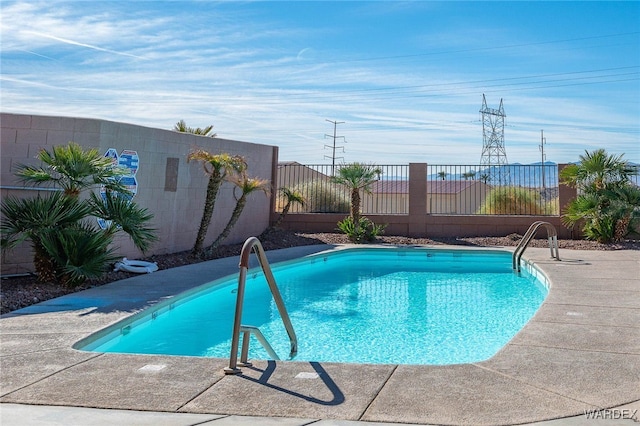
0 0 640 164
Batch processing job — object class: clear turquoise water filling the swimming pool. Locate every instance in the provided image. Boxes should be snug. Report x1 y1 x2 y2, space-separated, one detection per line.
83 248 547 365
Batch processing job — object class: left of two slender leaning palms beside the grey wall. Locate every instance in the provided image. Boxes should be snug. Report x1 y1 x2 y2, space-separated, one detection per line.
187 149 247 255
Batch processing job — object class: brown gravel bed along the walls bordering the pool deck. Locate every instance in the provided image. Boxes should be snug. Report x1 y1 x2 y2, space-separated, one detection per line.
0 231 640 314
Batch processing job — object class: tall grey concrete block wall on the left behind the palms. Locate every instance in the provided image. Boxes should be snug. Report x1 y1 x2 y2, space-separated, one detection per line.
0 113 278 274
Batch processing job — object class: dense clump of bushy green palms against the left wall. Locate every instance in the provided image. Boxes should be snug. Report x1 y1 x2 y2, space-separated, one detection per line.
0 142 157 285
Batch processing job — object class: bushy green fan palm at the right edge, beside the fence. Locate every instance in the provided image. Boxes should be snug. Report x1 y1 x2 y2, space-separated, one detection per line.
560 149 640 242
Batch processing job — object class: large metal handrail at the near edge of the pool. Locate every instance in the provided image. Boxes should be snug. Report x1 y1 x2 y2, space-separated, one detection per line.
224 237 298 374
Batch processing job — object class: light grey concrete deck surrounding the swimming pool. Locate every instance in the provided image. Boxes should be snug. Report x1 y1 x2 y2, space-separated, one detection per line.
0 246 640 426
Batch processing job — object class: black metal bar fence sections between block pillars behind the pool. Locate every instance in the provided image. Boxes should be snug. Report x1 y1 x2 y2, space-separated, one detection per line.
276 163 560 216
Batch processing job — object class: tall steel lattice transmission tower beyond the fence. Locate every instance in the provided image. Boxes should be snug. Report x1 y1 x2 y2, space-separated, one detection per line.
480 94 510 185
